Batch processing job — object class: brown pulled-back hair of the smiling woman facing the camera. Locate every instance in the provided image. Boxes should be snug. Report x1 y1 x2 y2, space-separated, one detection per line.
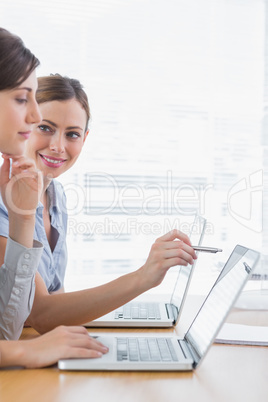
36 74 91 130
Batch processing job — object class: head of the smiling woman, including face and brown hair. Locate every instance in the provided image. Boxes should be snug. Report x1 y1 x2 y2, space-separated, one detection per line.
27 74 90 177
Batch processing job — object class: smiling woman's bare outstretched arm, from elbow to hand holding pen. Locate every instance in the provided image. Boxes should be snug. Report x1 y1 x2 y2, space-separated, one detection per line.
27 230 196 333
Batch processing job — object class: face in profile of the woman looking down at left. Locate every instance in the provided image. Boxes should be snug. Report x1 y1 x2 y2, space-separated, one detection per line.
0 71 41 156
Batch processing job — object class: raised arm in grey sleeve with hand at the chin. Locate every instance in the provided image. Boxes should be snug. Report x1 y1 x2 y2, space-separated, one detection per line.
0 157 43 339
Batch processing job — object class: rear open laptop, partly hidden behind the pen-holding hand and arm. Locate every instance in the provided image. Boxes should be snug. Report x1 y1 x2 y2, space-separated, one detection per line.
84 215 206 328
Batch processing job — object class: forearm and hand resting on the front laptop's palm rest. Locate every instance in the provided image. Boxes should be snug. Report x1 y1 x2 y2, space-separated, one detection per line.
0 326 108 368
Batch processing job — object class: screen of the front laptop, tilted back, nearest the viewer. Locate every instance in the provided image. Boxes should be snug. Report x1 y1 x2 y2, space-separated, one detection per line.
185 245 259 364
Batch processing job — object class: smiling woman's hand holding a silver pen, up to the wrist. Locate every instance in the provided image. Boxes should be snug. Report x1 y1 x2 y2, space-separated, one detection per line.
140 229 197 289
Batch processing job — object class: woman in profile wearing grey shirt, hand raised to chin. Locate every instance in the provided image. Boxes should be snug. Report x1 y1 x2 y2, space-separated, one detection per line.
0 28 107 368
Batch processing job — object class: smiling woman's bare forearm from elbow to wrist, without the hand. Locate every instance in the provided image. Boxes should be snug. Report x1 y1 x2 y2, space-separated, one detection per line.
27 270 147 333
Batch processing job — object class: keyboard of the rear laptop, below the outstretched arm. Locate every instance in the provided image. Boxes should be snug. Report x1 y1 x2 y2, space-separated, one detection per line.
115 302 161 320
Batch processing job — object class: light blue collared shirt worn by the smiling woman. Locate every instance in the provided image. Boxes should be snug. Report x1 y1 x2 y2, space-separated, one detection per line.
0 180 68 292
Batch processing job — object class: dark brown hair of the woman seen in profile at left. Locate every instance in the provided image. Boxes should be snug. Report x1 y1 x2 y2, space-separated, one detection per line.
0 28 40 91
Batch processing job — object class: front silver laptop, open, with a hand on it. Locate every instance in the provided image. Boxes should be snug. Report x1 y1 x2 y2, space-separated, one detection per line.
58 245 259 371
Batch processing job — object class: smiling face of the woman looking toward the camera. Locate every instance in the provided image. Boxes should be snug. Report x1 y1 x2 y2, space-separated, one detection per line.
26 99 88 178
